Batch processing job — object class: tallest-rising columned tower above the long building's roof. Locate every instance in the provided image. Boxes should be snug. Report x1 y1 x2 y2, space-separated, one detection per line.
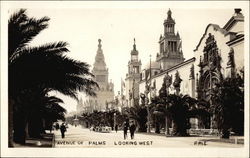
156 9 184 70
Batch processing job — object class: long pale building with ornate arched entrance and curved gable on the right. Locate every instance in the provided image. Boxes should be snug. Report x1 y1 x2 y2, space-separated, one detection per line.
139 9 246 128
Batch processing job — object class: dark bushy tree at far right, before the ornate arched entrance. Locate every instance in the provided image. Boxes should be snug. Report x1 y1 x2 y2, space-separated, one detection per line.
212 74 244 139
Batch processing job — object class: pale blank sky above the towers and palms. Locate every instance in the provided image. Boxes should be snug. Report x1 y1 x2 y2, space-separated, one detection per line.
3 2 248 112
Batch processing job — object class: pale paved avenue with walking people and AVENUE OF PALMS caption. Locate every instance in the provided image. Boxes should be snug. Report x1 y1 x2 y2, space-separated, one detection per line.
55 126 243 148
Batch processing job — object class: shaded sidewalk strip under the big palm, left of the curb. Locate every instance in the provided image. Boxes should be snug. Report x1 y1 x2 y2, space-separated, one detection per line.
13 133 55 148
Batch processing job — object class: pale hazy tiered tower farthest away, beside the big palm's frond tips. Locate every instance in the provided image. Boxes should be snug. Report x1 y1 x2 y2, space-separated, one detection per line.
84 39 114 112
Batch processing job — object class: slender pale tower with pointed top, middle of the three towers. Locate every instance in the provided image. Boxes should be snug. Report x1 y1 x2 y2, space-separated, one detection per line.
125 39 141 107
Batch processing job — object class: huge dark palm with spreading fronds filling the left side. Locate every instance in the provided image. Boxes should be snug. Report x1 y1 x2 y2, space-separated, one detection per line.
8 9 98 146
